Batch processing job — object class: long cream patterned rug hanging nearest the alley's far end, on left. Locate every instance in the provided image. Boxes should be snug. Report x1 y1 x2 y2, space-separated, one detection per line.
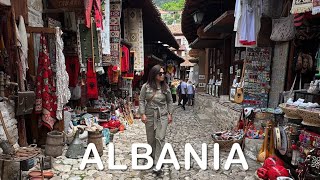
124 9 144 72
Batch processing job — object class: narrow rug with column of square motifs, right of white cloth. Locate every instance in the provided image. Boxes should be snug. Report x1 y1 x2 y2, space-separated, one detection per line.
102 0 122 67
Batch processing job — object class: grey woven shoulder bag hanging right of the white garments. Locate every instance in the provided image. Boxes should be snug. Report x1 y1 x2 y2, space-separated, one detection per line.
270 1 296 41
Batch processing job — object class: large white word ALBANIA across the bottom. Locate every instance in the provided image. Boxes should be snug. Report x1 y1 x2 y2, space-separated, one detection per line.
80 143 249 170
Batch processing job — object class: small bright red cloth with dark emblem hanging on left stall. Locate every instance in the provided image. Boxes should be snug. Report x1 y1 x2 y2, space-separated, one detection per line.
87 58 99 99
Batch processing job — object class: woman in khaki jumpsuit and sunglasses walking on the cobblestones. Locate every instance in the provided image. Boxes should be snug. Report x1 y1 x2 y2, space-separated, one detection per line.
139 65 173 172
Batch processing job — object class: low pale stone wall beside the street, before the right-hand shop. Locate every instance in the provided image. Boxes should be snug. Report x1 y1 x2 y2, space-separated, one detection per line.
195 94 242 130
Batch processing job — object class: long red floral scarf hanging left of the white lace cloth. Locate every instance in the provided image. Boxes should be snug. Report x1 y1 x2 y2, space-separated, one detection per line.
35 35 57 130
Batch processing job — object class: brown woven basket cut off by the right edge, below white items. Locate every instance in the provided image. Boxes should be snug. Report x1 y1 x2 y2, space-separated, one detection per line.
298 109 320 127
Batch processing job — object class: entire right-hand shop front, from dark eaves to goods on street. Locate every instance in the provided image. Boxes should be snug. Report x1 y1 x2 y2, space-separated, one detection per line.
182 0 320 179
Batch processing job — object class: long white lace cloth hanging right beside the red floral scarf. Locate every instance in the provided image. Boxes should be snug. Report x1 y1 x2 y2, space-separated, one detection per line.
56 27 71 120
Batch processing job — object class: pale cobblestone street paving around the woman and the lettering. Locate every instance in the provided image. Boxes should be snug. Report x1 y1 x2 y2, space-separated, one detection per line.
26 103 259 180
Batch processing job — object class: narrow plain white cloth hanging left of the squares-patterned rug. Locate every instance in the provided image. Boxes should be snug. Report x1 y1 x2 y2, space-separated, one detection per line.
101 0 110 55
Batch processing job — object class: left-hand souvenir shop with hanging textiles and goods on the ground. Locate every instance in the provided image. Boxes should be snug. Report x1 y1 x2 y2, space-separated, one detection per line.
0 1 138 179
